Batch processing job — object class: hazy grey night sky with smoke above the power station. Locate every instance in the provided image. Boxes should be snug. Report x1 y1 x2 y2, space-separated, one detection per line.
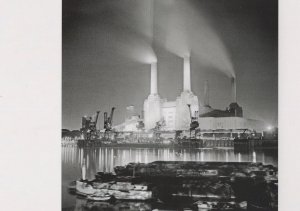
62 0 278 129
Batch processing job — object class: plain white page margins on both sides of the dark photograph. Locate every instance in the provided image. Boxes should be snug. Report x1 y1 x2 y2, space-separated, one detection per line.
0 0 300 211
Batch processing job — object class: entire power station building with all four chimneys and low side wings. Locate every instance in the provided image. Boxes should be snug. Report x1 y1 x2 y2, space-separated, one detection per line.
115 56 266 133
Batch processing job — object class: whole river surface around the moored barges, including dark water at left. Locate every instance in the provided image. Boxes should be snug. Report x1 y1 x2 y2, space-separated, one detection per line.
62 147 278 210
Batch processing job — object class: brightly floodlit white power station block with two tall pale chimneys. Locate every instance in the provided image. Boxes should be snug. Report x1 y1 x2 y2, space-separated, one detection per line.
144 57 199 130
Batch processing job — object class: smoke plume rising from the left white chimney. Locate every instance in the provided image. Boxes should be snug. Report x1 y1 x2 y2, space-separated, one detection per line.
112 0 157 64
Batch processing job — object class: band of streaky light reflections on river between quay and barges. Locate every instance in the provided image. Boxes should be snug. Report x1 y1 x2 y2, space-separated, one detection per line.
62 147 277 179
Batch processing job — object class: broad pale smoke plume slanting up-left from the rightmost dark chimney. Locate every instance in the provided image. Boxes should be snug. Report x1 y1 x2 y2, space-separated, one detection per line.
156 0 235 77
